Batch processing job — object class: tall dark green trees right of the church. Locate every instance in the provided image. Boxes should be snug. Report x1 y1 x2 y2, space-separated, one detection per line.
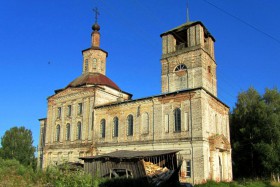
230 88 280 178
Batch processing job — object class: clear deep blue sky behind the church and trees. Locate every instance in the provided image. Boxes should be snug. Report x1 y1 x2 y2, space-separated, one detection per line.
0 0 280 149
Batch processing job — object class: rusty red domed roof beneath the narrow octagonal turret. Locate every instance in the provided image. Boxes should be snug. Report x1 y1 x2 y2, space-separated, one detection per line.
67 73 120 90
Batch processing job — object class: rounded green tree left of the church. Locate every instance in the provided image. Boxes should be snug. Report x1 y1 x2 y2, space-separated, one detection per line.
0 127 35 167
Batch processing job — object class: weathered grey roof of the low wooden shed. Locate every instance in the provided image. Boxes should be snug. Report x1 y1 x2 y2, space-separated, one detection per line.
80 150 180 160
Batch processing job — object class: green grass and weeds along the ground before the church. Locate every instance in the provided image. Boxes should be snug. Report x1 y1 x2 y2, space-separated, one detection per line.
0 158 280 187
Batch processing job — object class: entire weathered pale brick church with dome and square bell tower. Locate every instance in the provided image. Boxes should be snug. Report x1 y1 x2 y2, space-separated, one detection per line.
38 16 232 183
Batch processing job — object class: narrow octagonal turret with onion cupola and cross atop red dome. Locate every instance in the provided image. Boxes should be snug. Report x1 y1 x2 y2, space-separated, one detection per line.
82 8 108 75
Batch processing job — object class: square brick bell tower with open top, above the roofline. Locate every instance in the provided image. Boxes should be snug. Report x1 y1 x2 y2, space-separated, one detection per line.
160 21 217 96
